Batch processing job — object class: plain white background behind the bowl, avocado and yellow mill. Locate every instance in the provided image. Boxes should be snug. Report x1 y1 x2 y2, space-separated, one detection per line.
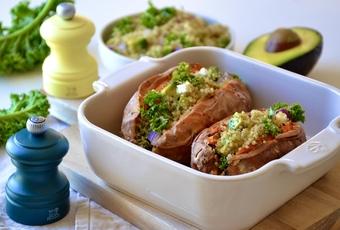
0 0 340 108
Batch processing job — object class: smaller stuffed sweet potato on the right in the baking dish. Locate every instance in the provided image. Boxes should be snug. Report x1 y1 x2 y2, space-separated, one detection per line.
191 103 306 175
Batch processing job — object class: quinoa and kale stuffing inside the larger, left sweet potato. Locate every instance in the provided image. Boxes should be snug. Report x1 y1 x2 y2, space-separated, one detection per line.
137 62 227 149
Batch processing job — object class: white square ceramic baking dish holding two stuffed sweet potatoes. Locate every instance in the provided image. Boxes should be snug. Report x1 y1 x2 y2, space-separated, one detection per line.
78 47 340 229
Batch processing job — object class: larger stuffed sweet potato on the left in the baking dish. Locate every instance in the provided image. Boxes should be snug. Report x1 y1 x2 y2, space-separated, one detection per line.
121 62 251 165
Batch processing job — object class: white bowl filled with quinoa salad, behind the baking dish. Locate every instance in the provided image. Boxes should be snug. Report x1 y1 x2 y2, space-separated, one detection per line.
99 2 233 70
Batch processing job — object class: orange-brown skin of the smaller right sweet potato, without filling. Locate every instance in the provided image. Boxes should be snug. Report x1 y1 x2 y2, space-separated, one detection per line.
190 117 306 175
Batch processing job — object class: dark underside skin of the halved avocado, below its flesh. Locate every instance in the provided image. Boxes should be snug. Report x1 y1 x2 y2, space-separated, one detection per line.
279 42 322 75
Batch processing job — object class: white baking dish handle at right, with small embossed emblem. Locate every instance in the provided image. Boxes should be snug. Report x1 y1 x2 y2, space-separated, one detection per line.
283 116 340 173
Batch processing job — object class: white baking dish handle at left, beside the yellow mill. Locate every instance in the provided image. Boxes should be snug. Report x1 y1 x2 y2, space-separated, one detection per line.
92 57 158 92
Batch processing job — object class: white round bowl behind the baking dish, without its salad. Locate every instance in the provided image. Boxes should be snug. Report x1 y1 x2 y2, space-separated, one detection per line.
98 11 235 72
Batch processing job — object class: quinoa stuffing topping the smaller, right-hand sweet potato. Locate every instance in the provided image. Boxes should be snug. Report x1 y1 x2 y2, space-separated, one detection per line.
215 102 305 169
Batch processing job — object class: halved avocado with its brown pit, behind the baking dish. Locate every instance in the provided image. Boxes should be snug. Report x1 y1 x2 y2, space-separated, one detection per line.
243 27 323 75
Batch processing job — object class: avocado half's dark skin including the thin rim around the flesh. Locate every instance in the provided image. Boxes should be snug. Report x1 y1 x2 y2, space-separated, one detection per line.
243 27 323 75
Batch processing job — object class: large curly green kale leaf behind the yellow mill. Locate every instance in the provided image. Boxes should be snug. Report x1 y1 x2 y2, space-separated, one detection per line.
0 0 72 74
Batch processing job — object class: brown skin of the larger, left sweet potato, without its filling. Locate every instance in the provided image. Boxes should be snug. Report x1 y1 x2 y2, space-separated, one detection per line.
121 66 252 166
